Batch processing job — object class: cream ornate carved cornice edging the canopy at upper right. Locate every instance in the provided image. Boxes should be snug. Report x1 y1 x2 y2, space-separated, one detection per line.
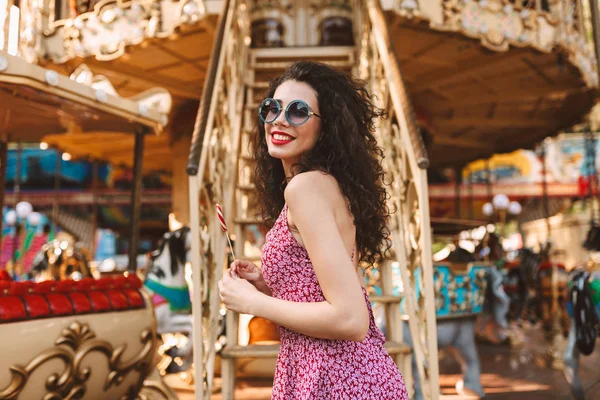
395 0 598 86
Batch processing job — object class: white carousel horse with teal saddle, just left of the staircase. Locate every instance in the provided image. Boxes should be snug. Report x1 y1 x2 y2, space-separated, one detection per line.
144 227 193 366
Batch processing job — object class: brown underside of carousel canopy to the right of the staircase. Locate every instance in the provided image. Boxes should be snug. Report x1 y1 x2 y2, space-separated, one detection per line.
390 7 598 166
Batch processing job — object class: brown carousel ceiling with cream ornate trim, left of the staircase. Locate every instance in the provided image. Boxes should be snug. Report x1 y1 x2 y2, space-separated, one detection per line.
29 0 221 171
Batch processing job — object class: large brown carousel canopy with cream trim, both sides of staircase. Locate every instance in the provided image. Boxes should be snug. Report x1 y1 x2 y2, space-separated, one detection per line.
30 0 598 167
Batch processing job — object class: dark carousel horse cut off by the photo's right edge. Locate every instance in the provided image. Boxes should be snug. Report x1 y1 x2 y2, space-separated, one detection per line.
563 271 600 400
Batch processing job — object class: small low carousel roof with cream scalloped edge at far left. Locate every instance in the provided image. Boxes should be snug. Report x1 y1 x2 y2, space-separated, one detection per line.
0 53 171 170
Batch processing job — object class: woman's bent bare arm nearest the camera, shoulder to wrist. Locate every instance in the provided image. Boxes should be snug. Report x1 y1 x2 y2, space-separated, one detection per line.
241 171 369 341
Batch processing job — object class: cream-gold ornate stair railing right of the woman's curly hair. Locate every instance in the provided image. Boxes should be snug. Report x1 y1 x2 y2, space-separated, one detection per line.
355 0 439 399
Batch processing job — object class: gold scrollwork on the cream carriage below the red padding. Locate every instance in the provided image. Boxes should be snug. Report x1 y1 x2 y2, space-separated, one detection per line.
0 322 155 400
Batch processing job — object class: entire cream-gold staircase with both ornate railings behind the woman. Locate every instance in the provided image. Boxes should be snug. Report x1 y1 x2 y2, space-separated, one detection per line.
188 0 439 399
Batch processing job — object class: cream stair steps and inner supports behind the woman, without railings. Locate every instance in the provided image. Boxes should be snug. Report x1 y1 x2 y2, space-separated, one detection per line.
221 47 411 399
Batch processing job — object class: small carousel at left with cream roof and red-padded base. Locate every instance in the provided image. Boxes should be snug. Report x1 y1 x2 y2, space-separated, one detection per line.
0 47 174 399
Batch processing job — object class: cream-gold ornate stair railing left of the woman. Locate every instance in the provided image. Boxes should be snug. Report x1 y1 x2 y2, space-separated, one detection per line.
187 0 250 399
